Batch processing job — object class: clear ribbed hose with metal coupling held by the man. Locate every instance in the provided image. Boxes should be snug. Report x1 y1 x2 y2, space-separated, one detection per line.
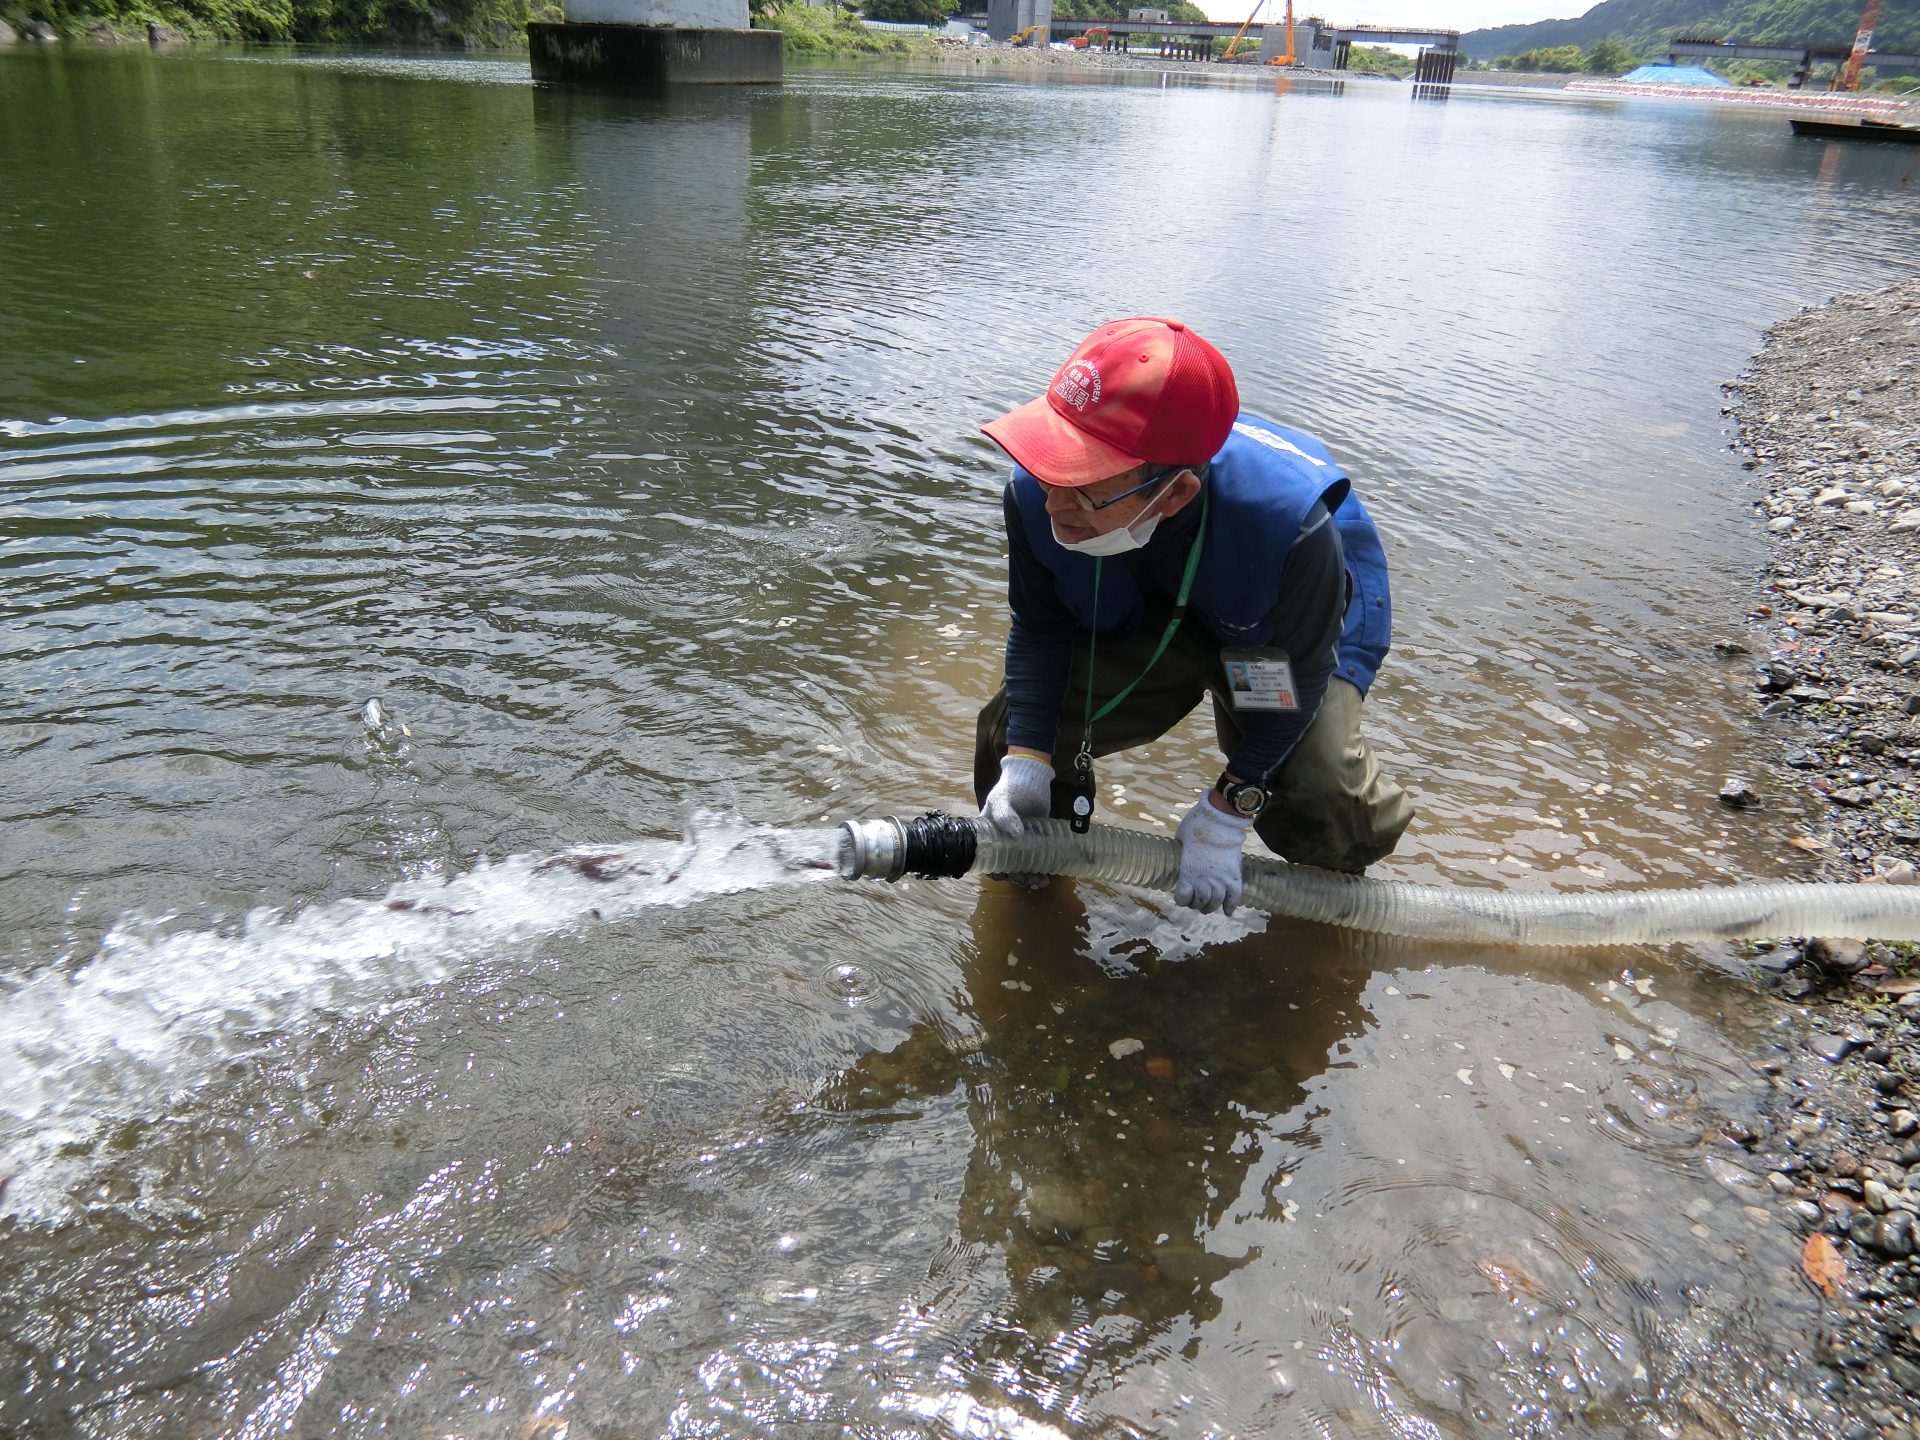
835 814 1920 945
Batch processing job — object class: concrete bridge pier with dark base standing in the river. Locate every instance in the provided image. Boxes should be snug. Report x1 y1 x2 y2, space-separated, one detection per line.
526 0 785 92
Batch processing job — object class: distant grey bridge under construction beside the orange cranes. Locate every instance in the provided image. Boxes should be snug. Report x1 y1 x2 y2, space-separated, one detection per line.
987 0 1459 74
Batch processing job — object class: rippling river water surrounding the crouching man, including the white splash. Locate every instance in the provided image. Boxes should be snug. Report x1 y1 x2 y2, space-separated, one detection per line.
0 52 1920 1440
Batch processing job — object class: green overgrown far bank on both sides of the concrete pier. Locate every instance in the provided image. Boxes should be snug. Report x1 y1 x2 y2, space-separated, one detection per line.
0 0 933 56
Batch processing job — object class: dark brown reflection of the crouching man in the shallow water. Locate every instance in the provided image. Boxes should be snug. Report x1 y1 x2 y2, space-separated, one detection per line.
828 881 1363 1367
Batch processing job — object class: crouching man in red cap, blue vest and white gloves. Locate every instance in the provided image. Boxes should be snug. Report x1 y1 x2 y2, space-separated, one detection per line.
973 319 1413 914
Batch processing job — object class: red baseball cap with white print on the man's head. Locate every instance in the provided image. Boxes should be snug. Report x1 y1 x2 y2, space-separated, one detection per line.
981 317 1240 486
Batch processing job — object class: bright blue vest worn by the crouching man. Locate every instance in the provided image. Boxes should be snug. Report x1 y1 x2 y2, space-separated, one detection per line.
1014 411 1392 695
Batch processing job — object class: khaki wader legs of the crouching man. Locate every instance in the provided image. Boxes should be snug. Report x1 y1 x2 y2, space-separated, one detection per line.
973 624 1413 874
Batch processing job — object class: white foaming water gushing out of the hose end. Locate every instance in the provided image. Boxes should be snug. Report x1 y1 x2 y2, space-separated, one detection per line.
0 816 835 1217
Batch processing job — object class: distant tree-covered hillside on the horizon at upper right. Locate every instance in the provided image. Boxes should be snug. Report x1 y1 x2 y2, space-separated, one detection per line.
1459 0 1920 60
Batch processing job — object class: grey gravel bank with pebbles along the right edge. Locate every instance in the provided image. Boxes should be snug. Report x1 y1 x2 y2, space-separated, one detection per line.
1722 280 1920 1440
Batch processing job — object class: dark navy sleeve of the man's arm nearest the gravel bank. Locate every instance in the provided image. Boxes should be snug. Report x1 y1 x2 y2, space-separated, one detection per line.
1227 505 1348 783
